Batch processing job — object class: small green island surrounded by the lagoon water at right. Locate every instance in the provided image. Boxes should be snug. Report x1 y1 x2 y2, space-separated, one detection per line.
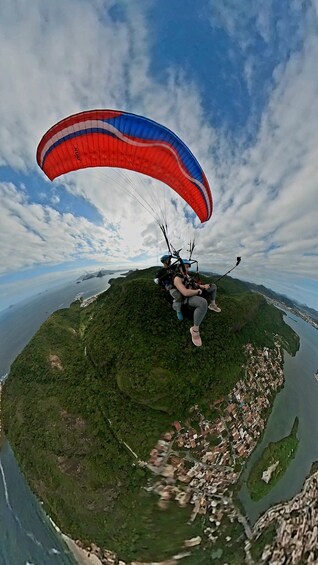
247 418 299 500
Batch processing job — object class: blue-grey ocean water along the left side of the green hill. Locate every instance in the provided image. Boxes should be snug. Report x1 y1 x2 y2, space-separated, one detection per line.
0 272 124 565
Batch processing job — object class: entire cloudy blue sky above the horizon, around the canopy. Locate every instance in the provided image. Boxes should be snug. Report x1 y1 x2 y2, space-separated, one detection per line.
0 0 318 310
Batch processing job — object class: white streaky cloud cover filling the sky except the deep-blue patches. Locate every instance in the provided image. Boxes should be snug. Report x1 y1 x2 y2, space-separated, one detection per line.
0 0 318 308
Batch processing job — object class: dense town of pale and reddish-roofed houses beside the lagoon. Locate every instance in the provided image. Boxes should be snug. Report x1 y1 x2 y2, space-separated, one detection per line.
74 336 318 565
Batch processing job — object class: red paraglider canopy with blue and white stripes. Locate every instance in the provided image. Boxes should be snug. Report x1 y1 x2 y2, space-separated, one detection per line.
37 110 213 222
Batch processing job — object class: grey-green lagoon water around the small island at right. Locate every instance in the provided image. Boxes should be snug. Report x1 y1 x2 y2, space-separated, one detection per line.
239 313 318 524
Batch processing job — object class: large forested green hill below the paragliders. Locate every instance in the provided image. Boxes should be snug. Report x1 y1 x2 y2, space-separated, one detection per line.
3 268 298 560
